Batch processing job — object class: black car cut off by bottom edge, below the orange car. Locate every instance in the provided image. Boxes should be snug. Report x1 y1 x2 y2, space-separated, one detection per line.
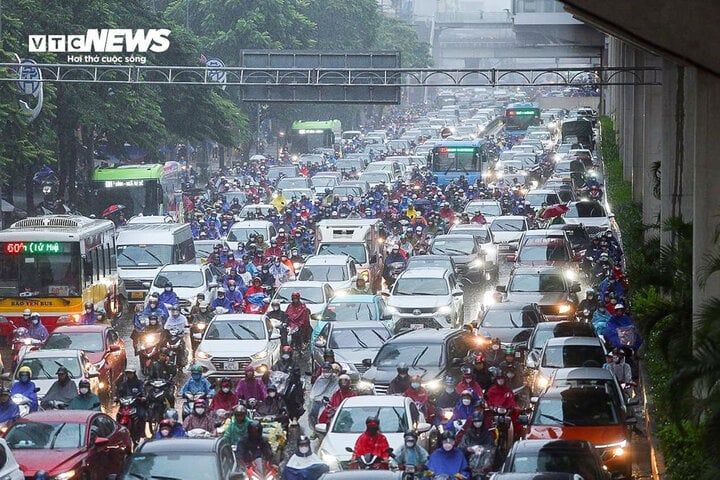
493 439 609 480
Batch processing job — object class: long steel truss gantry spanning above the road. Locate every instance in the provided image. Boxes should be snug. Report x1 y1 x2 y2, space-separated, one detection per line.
0 63 661 87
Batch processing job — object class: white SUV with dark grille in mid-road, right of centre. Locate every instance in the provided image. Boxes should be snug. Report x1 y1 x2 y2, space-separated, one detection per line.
387 267 465 332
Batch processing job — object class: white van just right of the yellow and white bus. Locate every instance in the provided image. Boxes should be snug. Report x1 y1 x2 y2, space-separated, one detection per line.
116 221 195 304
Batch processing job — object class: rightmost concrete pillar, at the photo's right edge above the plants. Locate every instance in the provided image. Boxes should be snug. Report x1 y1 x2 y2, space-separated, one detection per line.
686 68 720 334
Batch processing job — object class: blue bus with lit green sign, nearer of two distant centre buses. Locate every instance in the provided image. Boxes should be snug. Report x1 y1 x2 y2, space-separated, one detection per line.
429 140 489 185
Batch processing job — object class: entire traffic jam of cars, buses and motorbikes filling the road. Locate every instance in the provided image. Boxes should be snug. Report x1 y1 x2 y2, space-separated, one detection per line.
0 88 644 480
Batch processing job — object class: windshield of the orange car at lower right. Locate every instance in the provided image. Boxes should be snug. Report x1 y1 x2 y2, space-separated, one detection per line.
533 388 620 427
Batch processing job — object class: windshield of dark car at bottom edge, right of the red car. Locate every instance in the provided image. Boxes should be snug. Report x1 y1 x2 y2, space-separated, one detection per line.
125 451 220 480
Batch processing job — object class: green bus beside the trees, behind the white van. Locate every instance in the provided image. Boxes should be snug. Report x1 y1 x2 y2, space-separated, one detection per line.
92 162 182 218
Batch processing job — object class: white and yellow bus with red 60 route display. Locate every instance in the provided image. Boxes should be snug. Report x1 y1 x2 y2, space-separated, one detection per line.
0 215 123 335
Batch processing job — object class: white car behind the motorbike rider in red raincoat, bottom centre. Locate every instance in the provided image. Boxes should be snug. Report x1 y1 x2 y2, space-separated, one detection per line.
315 395 432 470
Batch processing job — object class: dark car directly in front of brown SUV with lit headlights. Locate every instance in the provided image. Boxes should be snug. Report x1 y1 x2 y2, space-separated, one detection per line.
475 302 545 347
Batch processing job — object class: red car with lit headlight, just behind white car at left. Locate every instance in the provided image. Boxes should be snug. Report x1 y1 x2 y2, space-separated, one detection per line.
42 323 127 394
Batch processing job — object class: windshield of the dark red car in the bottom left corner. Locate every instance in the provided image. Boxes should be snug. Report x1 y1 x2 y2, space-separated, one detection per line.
5 422 85 450
